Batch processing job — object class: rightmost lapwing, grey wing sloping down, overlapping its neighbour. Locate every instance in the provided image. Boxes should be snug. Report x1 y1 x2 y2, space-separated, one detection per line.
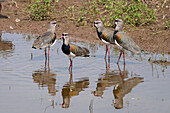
113 19 143 64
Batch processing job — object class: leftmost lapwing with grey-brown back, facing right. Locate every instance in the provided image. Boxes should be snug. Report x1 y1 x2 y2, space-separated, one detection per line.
32 21 57 59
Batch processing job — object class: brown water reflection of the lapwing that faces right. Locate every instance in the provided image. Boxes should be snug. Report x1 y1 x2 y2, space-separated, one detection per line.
32 57 58 110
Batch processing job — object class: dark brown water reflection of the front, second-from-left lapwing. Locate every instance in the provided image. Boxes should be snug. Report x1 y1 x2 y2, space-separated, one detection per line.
62 71 89 108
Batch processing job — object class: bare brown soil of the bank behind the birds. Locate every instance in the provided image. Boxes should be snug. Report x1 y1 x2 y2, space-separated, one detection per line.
0 0 170 54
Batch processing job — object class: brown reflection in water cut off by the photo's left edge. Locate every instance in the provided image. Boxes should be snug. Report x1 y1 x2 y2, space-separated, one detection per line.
0 32 15 58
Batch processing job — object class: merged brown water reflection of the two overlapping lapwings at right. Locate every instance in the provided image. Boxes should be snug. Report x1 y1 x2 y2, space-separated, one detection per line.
92 62 144 109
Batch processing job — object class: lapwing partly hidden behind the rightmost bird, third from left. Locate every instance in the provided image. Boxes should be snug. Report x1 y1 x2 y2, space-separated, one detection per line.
93 21 115 60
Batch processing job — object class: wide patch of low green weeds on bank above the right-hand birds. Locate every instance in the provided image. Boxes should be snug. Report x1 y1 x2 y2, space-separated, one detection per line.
65 0 156 26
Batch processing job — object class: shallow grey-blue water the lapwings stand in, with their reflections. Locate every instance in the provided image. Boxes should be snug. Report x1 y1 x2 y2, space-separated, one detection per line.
0 33 170 113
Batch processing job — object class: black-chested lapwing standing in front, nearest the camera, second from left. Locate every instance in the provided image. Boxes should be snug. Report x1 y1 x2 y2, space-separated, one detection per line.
61 33 90 71
